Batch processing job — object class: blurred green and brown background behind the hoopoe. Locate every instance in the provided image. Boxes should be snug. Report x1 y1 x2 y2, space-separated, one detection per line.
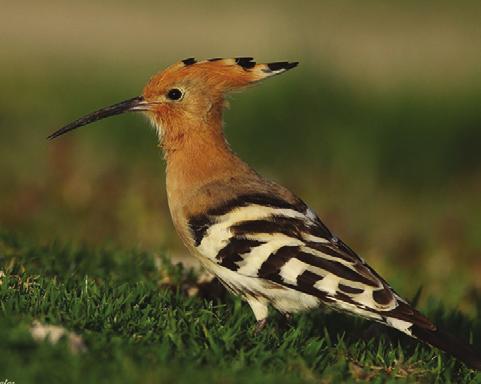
0 0 481 311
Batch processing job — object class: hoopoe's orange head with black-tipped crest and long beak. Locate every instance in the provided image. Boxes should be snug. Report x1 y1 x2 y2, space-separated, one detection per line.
49 57 297 147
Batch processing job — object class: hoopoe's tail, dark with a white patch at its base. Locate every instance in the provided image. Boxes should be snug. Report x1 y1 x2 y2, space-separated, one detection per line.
386 302 481 371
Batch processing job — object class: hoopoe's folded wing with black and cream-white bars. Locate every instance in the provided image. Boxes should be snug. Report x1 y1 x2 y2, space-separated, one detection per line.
190 195 433 334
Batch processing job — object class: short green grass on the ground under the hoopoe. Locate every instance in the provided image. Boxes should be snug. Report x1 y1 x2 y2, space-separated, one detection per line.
0 232 481 383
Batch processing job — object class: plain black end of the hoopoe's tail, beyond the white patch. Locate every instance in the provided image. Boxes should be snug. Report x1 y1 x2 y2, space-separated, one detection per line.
411 324 481 371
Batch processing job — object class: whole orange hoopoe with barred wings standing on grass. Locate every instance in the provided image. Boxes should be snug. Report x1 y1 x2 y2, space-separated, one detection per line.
49 57 481 369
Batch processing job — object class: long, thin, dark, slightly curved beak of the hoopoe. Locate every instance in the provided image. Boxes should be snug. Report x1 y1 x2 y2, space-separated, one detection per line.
47 96 148 140
